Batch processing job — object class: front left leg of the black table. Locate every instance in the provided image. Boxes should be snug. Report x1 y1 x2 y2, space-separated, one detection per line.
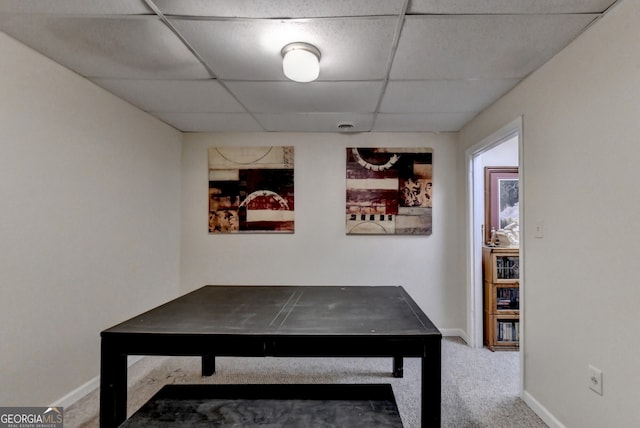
100 339 127 428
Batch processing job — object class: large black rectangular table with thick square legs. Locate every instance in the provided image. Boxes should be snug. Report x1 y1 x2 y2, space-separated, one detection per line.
100 286 442 428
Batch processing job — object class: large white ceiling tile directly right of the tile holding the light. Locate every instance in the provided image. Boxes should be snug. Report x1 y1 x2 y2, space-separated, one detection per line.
391 14 596 79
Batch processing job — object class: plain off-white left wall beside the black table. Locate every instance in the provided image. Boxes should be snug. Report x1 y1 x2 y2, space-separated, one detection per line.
0 33 182 406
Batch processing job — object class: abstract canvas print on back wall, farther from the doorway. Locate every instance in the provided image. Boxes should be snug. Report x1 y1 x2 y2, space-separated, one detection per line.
209 146 294 234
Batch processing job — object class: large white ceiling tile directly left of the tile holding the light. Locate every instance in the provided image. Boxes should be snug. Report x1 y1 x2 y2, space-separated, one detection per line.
0 14 210 79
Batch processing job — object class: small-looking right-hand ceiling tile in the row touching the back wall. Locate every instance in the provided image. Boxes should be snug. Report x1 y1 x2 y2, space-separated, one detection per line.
373 112 477 132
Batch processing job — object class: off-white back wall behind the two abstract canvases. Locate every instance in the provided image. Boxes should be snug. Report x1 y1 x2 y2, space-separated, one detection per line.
181 133 466 329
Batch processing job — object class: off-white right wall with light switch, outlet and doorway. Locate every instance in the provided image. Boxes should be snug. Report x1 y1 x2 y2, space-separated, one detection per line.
460 0 640 428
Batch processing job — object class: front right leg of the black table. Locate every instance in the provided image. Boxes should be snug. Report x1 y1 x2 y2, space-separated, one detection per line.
421 340 442 428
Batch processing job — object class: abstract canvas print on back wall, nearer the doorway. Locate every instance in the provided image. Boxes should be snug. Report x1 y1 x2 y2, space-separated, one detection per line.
346 148 433 235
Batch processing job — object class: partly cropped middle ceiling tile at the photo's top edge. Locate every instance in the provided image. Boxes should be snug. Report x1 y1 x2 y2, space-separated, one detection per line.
154 0 402 18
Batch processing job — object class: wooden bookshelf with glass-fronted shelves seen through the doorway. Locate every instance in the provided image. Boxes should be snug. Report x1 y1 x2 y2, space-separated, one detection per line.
482 247 520 351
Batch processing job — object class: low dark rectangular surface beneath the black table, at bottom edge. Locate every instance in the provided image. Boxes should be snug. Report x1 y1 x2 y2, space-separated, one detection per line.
120 384 402 428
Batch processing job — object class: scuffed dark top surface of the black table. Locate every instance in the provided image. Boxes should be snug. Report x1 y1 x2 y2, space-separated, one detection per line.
102 285 441 337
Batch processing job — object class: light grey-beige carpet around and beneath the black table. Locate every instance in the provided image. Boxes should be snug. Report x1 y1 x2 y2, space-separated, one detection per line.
64 337 547 428
